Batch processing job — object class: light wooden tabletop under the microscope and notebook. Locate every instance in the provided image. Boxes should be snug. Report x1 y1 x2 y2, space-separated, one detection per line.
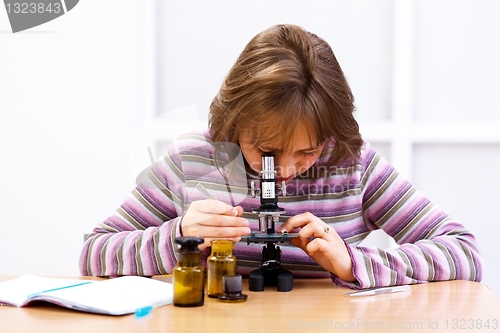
0 276 500 333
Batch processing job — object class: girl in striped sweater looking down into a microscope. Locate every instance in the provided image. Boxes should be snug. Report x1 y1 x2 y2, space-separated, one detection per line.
80 25 483 288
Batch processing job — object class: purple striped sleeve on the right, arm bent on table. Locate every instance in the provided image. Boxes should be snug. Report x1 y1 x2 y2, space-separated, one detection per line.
332 151 483 288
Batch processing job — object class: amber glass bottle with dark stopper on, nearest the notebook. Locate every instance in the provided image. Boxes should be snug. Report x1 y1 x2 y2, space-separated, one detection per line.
172 237 205 307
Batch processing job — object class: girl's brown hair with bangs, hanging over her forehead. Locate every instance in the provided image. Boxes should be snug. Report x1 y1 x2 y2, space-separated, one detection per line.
209 25 363 165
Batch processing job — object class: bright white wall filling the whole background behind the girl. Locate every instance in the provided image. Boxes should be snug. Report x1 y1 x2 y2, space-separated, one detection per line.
0 0 500 295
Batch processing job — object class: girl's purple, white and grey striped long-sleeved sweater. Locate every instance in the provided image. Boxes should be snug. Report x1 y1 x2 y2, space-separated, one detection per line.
80 133 483 288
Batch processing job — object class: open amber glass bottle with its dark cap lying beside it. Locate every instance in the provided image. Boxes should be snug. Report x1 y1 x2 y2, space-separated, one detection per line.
207 239 237 298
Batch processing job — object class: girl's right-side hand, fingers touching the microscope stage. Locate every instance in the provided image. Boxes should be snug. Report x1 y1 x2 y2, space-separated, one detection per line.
277 213 356 281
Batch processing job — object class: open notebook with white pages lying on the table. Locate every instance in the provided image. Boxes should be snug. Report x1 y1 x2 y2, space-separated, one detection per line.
0 274 173 316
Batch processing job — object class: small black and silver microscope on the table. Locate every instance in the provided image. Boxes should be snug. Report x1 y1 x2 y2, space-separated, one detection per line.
246 153 293 292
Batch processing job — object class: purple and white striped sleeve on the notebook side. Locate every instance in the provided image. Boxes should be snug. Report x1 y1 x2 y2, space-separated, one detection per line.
80 140 184 276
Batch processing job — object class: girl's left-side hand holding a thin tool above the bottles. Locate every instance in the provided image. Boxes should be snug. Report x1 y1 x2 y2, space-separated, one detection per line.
181 199 250 250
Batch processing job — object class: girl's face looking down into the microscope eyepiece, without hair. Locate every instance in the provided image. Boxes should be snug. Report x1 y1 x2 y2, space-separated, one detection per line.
239 125 325 183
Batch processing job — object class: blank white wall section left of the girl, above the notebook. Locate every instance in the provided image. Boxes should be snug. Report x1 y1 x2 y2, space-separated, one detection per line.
0 0 153 275
